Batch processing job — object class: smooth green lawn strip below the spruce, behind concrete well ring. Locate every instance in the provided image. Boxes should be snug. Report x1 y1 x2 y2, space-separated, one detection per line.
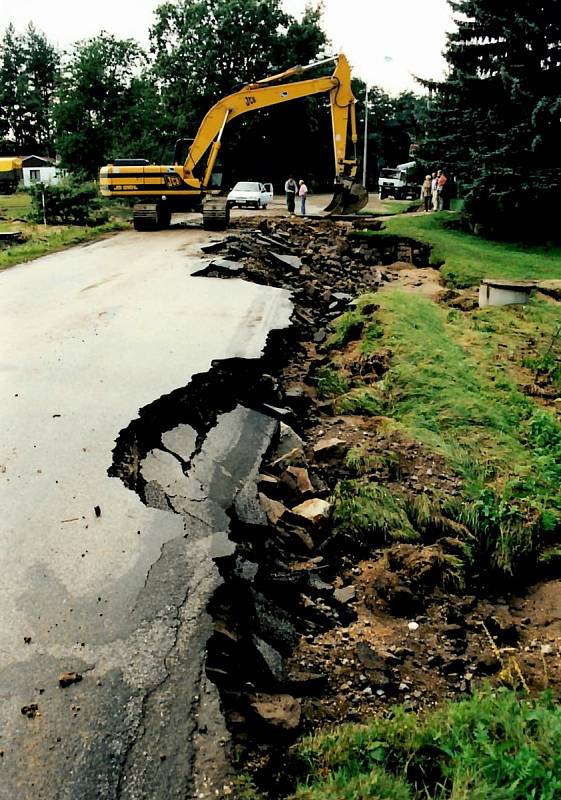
352 212 561 288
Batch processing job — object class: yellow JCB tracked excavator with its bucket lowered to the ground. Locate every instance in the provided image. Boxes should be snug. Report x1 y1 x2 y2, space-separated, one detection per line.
99 53 368 231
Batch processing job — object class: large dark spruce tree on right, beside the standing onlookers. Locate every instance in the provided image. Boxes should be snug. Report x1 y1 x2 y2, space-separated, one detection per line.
423 0 561 237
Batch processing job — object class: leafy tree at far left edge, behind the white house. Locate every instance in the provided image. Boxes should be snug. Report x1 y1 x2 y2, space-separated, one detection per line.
0 24 59 154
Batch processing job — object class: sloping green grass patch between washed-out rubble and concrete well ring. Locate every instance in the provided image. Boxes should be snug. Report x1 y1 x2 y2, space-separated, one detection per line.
322 290 561 575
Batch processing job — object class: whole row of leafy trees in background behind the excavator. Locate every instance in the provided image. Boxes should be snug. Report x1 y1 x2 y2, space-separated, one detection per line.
0 0 428 189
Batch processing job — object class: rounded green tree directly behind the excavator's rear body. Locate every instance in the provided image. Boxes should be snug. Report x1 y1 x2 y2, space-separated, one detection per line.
54 33 159 177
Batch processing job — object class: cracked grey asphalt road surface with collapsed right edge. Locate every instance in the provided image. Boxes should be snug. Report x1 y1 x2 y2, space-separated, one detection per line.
0 229 290 800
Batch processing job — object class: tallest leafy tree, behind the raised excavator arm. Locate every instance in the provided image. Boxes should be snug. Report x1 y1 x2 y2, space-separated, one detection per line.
151 0 331 188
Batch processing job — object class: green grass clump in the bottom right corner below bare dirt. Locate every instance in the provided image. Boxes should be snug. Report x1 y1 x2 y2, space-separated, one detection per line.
291 688 561 800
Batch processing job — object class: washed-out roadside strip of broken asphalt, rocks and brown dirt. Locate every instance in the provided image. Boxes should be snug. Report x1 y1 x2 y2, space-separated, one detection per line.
191 220 561 797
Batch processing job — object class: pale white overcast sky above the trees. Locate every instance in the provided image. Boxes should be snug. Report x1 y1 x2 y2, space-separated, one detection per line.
0 0 453 93
